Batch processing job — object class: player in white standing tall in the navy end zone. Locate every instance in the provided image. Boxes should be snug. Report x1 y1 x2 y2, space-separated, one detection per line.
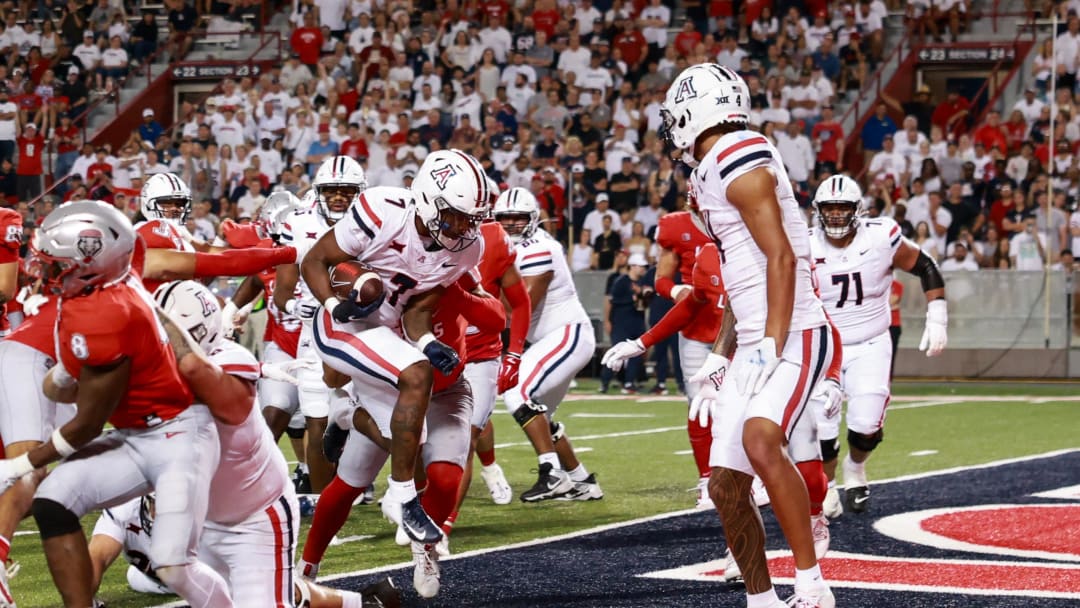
661 64 836 608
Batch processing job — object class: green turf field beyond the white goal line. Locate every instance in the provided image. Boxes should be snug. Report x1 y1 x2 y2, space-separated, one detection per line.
11 381 1080 608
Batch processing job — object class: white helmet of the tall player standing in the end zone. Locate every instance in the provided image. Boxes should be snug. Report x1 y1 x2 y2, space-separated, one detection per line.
660 64 750 166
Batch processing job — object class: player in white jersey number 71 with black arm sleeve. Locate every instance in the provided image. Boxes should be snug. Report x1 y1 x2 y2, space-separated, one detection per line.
810 175 948 517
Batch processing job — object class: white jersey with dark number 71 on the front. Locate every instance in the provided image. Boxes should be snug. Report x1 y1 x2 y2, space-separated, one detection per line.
810 217 904 346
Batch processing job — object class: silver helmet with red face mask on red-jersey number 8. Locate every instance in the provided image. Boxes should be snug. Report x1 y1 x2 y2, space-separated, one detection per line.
27 201 136 298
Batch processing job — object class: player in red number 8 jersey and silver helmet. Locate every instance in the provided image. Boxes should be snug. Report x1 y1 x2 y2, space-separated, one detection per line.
0 201 232 608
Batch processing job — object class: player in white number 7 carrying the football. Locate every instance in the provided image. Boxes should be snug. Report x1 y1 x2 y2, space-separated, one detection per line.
302 149 489 544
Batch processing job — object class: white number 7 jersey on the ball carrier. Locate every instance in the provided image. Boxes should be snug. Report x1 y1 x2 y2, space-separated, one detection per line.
334 187 484 329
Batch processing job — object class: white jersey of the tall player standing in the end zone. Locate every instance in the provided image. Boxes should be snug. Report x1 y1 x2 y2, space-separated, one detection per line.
690 131 825 346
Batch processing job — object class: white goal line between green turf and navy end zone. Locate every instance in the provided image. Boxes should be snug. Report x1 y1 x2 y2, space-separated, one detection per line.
157 449 1080 608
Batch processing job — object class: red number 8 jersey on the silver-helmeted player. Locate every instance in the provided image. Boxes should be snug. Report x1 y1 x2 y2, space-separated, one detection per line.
56 281 192 429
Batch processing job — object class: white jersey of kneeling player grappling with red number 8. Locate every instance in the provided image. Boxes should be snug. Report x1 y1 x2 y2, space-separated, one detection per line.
206 341 291 526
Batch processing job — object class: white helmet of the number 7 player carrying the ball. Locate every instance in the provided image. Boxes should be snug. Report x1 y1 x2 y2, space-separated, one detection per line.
409 149 491 252
